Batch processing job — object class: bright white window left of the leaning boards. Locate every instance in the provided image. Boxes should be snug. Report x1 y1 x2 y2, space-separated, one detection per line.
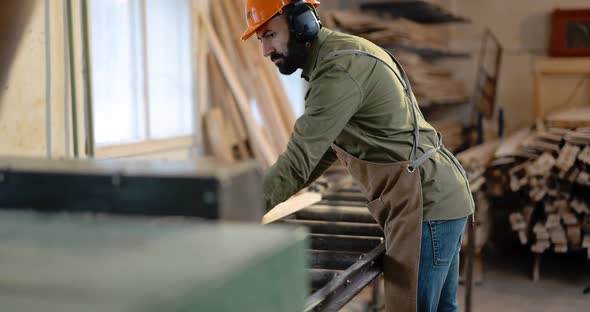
90 0 194 146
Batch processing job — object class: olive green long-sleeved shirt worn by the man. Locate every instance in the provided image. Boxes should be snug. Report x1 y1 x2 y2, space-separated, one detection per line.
263 28 474 221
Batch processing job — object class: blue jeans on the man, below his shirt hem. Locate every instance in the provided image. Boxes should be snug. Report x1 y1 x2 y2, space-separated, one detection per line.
418 218 467 312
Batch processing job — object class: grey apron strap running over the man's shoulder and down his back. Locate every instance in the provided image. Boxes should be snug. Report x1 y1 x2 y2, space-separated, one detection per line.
326 49 420 162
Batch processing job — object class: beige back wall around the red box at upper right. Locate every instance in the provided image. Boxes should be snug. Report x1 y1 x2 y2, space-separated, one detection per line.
446 0 590 132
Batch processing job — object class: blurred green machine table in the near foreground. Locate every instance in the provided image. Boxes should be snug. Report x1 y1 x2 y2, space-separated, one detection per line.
0 211 308 312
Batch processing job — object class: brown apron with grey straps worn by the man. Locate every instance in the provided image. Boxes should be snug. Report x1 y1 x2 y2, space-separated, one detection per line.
328 50 454 312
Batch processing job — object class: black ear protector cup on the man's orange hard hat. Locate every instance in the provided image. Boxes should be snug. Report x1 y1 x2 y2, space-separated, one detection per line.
287 0 320 42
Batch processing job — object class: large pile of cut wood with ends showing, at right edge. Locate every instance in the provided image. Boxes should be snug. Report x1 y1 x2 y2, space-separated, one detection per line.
488 128 590 258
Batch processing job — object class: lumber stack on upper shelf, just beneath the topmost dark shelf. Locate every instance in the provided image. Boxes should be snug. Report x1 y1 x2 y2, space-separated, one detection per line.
321 11 450 52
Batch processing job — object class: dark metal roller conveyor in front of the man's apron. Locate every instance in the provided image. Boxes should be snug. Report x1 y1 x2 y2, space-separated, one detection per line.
280 183 385 311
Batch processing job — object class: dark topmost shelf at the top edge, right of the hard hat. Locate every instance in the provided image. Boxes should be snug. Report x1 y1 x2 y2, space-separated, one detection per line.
360 0 470 24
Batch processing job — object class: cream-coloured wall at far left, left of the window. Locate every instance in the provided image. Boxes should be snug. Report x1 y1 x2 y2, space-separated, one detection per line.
0 0 83 157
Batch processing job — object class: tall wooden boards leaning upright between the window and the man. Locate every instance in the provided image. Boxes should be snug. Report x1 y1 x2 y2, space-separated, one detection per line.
193 0 295 167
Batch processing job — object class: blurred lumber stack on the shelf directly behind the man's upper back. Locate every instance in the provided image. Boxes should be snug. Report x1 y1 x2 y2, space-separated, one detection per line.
394 51 467 107
